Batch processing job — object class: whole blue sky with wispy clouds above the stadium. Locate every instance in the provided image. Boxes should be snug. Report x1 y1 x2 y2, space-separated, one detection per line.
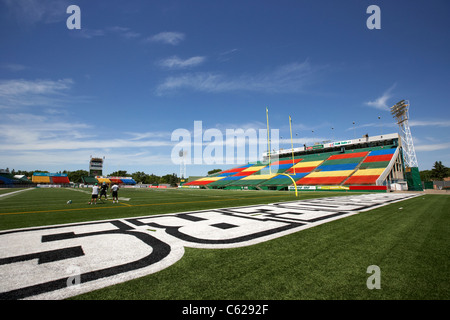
0 0 450 175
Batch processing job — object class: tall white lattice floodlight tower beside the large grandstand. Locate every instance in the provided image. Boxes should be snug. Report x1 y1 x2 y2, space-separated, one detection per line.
391 100 419 168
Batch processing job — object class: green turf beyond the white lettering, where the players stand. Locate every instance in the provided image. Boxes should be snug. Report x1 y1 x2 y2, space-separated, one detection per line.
0 188 342 230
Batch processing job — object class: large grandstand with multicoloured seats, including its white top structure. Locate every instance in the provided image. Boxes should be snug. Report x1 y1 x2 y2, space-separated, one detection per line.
183 133 421 192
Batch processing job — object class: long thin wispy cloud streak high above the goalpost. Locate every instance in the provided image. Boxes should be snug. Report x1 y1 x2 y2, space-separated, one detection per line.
156 61 318 95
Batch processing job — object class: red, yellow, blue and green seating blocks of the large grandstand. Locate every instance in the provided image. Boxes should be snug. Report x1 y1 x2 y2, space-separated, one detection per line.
184 146 397 190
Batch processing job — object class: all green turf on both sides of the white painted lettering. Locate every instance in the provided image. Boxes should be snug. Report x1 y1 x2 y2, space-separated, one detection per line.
0 189 450 300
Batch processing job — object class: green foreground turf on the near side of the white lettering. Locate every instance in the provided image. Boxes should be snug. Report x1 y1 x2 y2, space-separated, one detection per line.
67 195 450 300
